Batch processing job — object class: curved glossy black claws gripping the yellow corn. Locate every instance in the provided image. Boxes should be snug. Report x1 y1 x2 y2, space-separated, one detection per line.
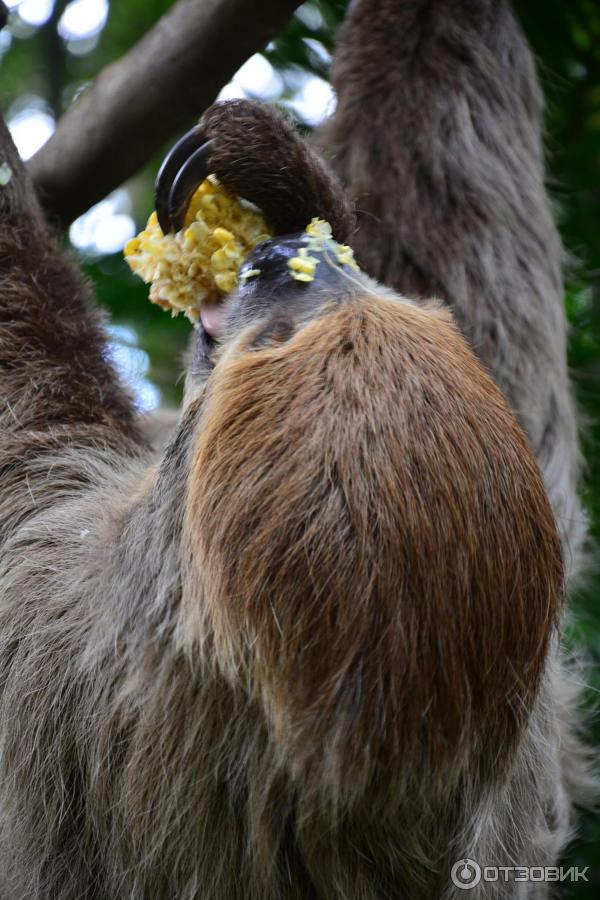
154 127 213 234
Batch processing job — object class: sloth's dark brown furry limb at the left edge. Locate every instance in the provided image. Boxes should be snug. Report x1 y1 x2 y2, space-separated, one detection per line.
0 121 143 438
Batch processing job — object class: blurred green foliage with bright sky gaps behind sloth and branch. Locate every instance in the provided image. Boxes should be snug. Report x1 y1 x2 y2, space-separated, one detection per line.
0 0 600 898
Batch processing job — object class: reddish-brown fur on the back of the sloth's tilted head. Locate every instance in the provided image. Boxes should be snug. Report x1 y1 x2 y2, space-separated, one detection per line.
184 295 562 805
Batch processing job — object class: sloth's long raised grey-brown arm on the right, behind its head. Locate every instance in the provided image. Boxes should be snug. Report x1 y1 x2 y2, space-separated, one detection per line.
320 0 585 572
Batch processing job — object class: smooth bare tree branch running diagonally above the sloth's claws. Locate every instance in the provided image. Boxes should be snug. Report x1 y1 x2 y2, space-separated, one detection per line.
29 0 300 227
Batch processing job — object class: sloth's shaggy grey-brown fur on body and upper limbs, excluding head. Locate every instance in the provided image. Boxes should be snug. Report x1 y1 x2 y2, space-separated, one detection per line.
0 0 585 900
